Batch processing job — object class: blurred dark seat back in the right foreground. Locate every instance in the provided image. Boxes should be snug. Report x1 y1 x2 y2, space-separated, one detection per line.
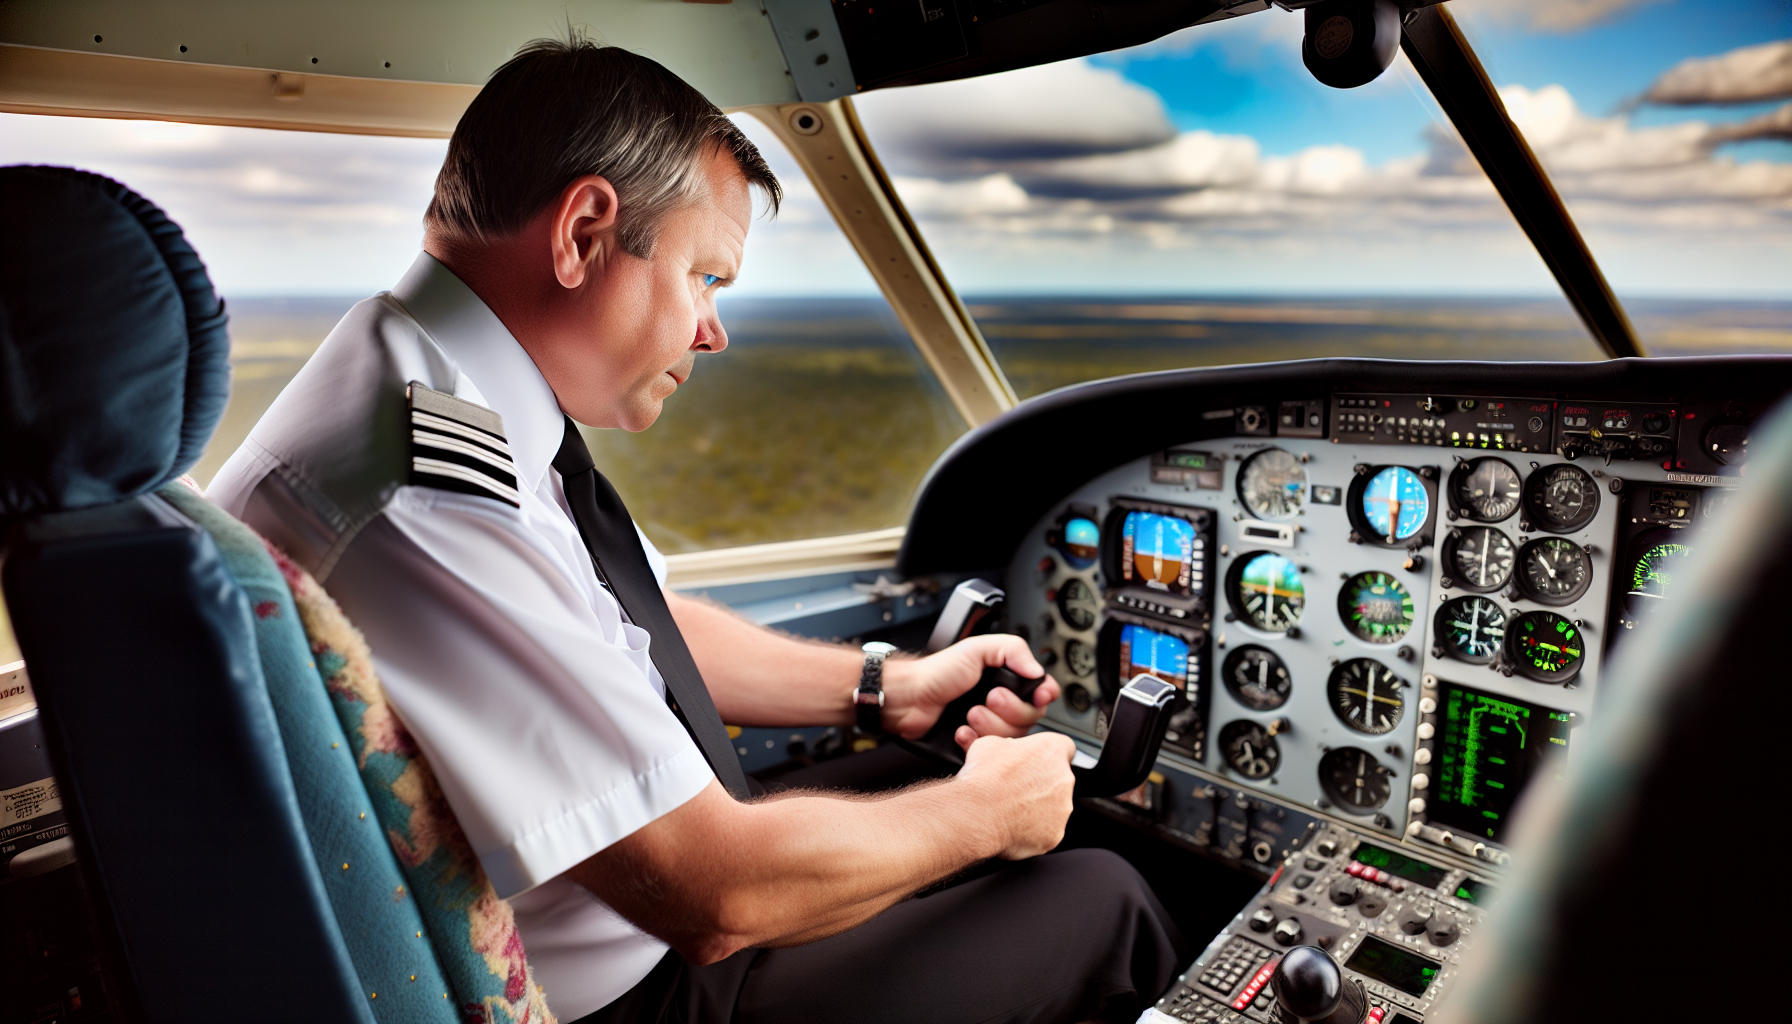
1435 404 1792 1024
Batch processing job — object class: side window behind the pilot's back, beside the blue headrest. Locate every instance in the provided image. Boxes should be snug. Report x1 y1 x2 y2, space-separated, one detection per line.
0 113 448 486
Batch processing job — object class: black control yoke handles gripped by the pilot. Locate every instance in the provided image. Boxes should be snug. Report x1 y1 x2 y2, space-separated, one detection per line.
901 665 1177 796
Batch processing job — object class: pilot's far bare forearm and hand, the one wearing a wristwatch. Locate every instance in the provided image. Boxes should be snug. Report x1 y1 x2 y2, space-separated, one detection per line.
665 590 1057 746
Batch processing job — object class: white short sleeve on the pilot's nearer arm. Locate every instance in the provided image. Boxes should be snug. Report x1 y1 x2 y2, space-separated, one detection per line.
328 488 715 897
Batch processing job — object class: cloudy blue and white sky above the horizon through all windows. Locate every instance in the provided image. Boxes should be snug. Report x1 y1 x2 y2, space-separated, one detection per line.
0 0 1792 299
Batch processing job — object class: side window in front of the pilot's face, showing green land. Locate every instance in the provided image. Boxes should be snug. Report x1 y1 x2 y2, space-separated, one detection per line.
586 115 964 554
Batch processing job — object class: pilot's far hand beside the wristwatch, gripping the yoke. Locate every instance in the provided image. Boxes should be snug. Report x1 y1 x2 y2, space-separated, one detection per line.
883 633 1068 757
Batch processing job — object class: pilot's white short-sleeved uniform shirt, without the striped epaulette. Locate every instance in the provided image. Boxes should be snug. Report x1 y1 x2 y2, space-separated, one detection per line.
210 253 713 1020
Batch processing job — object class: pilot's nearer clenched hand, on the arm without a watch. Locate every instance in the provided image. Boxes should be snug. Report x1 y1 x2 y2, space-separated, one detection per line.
957 732 1077 861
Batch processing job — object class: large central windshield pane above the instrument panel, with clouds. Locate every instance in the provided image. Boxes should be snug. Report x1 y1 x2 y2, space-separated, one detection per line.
855 9 1662 395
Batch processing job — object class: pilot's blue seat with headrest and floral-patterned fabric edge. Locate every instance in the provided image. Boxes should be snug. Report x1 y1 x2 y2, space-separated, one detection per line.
0 167 552 1022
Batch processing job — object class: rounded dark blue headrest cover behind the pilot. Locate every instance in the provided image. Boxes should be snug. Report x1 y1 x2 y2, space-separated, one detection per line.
0 167 229 518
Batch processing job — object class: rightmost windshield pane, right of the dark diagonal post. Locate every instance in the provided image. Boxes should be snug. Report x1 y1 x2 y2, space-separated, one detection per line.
1452 0 1792 355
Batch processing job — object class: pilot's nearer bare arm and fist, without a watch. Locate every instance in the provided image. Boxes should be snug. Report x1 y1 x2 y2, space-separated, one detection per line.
568 733 1075 965
